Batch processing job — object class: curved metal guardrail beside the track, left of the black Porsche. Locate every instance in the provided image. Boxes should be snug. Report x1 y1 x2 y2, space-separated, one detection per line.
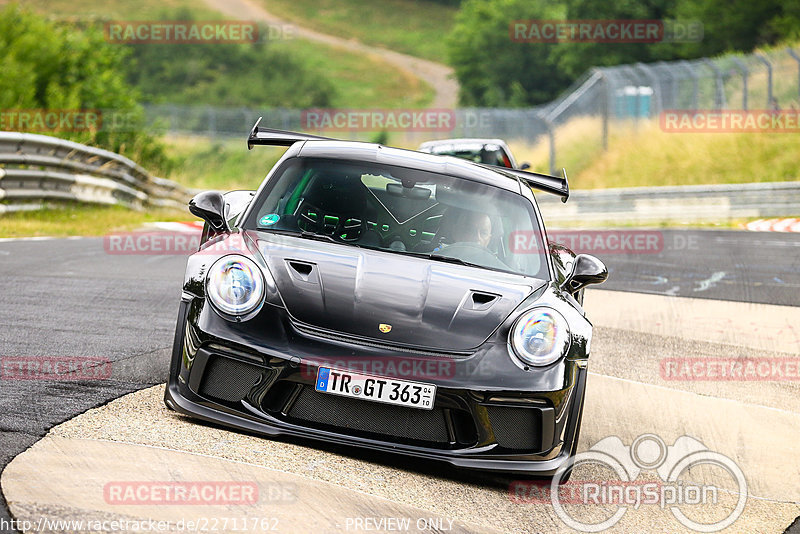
0 132 192 213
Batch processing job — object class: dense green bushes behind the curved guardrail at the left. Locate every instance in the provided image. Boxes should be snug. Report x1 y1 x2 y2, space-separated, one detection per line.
0 4 169 170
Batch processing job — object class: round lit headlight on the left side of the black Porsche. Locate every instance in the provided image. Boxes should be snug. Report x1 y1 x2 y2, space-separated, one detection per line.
206 255 264 316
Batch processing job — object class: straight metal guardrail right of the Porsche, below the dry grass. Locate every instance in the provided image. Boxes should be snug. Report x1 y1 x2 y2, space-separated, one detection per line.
536 181 800 224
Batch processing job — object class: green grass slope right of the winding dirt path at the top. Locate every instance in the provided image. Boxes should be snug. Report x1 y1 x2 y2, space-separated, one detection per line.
259 0 458 63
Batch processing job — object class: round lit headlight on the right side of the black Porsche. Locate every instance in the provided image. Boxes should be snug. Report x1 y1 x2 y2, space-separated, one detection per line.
510 308 570 366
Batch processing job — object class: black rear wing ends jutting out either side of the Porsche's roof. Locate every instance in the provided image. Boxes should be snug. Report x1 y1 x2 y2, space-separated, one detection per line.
247 117 569 202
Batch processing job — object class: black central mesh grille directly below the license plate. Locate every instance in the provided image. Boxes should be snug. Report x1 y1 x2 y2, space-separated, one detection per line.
288 387 450 444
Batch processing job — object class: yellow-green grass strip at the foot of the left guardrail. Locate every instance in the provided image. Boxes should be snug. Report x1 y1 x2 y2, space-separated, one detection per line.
0 204 188 238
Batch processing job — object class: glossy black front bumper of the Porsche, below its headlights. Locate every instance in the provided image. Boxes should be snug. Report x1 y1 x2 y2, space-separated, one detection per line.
165 298 586 476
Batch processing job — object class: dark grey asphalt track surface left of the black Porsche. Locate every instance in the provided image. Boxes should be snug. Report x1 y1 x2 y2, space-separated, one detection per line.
0 238 186 534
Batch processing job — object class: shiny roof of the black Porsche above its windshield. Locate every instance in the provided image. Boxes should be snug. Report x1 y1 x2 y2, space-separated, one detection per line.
297 140 520 193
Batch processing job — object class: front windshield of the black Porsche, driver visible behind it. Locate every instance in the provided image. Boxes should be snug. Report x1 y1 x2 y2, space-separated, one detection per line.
245 158 550 279
